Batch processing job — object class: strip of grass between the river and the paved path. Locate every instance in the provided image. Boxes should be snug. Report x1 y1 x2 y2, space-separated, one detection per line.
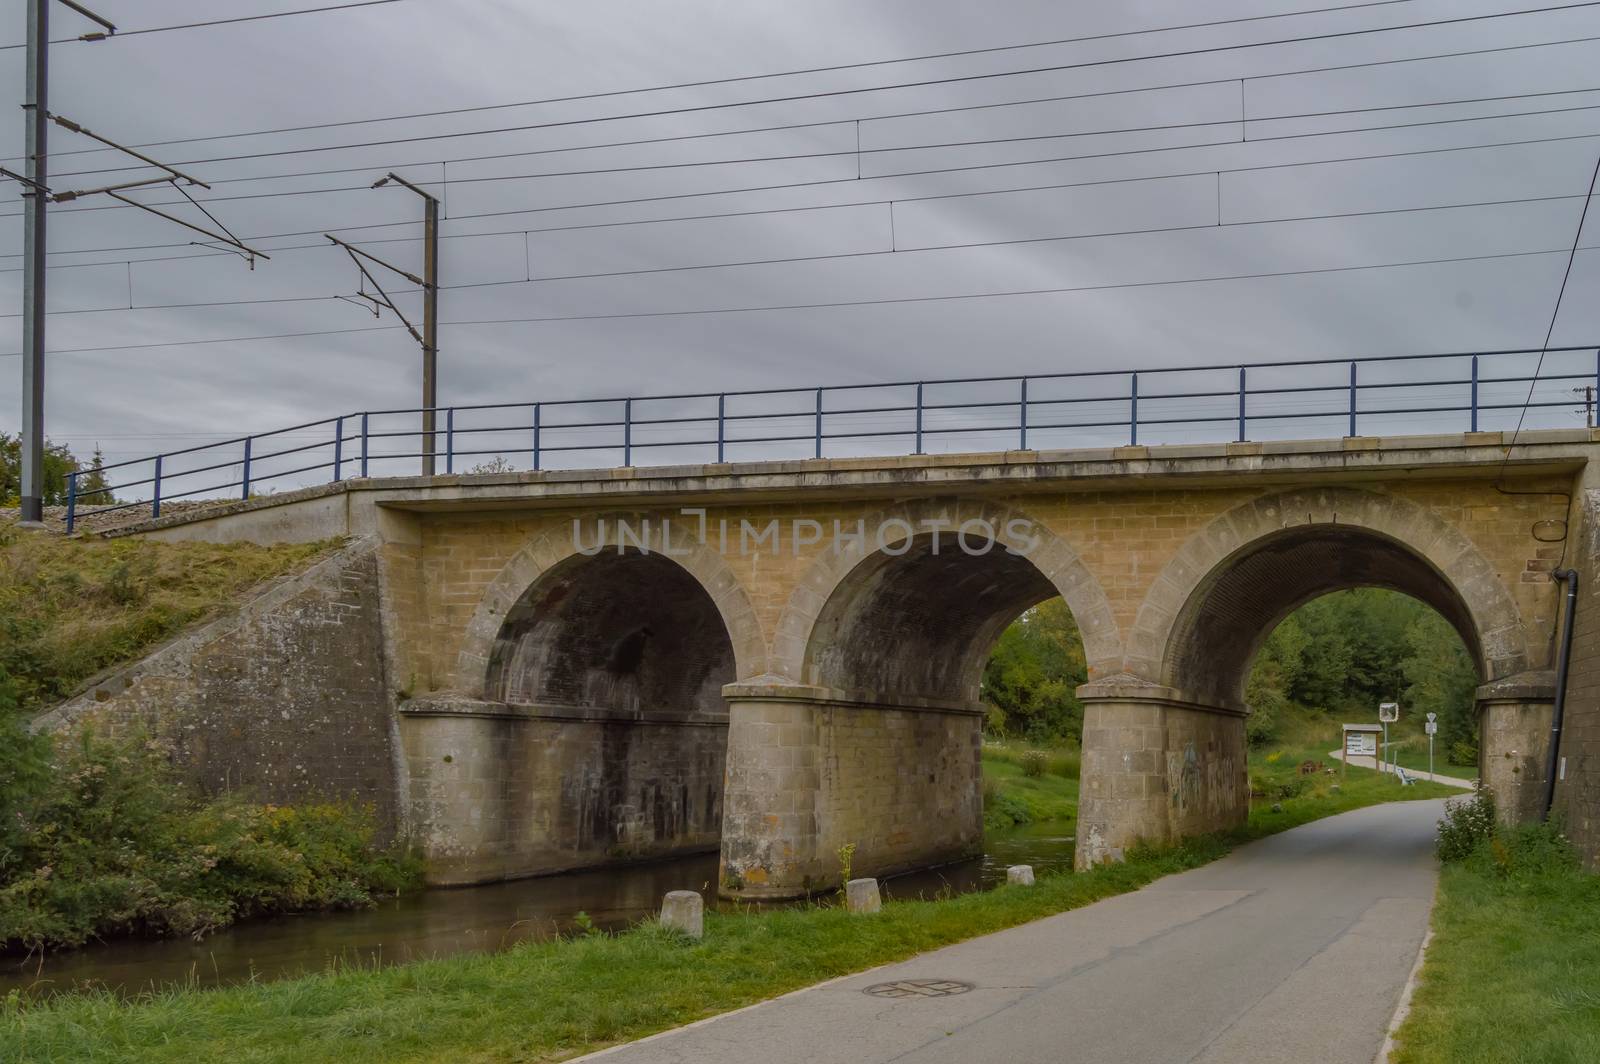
0 754 1445 1064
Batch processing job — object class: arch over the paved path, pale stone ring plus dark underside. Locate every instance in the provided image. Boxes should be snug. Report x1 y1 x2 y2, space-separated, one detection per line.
1125 488 1528 709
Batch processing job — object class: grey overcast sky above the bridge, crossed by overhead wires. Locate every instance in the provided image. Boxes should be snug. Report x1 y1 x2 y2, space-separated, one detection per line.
0 0 1600 486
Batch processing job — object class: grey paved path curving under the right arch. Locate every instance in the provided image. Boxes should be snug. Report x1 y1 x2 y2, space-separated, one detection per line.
582 802 1443 1064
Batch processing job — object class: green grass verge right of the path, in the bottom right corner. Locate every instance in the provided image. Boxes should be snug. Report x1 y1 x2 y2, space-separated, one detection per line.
1394 829 1600 1064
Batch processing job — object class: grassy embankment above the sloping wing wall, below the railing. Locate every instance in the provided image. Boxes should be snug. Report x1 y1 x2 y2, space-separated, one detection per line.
0 525 330 709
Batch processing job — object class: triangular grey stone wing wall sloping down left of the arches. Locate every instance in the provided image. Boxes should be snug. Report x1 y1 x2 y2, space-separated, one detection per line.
35 539 398 837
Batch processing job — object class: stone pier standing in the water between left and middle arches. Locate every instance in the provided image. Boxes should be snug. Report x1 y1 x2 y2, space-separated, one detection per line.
720 683 982 898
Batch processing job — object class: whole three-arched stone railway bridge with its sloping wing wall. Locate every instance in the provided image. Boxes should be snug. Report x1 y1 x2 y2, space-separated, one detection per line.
46 430 1600 898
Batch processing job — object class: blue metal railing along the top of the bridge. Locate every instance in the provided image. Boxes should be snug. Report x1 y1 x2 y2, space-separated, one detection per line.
67 344 1600 531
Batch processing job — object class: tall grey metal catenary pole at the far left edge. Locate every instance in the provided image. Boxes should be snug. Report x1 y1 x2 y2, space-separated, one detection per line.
21 0 51 525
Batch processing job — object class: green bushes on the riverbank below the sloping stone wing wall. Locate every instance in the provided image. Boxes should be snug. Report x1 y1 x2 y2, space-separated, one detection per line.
0 733 418 949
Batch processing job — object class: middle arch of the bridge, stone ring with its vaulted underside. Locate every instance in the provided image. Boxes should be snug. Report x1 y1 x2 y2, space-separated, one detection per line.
770 499 1122 701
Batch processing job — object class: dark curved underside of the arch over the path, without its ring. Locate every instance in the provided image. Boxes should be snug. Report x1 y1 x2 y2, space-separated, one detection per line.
1163 525 1485 709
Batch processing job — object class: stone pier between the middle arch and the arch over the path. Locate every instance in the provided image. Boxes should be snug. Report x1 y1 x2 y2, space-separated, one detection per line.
1074 677 1250 869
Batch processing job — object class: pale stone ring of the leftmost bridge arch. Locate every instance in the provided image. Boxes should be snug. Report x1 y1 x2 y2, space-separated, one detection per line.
451 514 766 698
